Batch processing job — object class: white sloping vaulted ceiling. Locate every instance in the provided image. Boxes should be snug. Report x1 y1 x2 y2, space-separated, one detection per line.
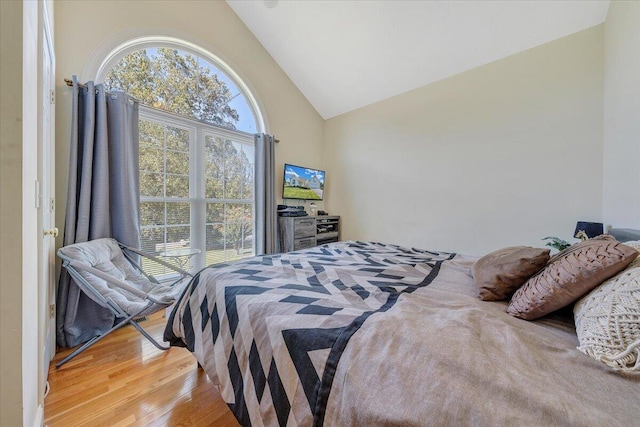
227 0 609 119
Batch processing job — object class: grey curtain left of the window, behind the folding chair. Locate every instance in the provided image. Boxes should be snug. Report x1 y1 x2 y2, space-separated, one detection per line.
56 76 140 347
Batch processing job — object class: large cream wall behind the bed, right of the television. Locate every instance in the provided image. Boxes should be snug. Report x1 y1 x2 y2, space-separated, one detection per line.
325 26 603 254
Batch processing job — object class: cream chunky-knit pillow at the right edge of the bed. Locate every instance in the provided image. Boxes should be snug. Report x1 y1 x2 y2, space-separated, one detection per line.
574 241 640 372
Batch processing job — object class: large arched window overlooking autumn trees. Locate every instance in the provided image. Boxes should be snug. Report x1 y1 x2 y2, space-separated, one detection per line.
99 43 263 274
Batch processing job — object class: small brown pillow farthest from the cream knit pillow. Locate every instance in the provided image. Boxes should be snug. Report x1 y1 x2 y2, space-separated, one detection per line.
471 246 549 301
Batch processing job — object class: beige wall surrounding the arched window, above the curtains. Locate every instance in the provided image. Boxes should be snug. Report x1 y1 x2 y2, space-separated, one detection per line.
55 0 324 237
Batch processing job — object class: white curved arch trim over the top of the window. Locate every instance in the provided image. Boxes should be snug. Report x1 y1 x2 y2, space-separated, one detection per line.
95 36 267 133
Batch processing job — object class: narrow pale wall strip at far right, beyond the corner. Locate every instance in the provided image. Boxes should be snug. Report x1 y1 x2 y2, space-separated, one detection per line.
603 1 640 228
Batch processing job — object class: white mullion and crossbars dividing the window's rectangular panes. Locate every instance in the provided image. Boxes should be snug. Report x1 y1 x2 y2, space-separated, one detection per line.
139 105 255 271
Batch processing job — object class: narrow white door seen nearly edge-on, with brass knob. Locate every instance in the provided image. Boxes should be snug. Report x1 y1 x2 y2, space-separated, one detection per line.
36 2 58 404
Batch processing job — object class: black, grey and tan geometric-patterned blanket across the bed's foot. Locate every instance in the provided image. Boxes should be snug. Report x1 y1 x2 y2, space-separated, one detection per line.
165 242 455 426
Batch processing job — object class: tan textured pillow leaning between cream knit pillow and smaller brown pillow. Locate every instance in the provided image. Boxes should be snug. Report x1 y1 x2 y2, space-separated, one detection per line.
507 235 638 320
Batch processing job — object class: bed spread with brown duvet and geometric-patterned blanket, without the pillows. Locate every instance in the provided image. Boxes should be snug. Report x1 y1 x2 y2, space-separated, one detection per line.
165 242 640 426
